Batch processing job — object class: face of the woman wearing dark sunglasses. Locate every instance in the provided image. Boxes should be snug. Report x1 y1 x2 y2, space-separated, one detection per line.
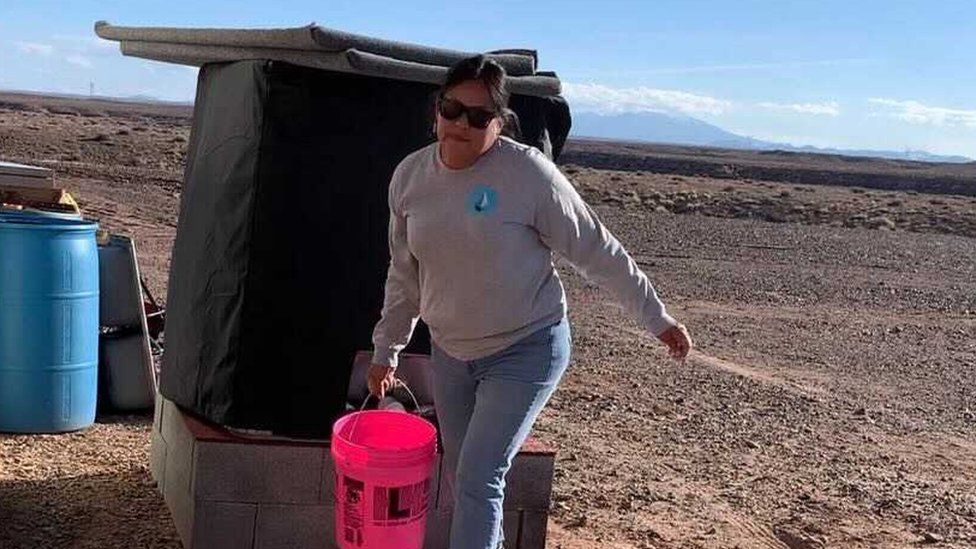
437 80 502 163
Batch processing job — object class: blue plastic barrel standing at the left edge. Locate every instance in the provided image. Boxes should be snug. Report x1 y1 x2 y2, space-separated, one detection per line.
0 213 98 433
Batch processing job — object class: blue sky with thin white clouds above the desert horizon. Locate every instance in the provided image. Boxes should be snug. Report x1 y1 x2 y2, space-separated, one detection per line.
0 0 976 158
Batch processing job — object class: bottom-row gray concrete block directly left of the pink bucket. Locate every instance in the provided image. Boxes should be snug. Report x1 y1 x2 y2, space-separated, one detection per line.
254 503 335 549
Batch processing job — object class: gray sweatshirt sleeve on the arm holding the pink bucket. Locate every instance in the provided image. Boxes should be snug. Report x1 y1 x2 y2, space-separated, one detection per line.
373 169 420 368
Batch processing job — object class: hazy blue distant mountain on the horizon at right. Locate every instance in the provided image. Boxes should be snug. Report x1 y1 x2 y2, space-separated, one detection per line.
572 112 973 163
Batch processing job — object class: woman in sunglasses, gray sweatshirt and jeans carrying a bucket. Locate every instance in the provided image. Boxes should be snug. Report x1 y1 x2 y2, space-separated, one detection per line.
369 56 691 549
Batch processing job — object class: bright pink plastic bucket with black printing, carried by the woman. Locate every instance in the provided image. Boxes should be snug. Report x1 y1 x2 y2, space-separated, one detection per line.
332 410 437 549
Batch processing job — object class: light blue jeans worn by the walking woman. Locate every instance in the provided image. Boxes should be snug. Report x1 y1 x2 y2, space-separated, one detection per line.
431 317 571 549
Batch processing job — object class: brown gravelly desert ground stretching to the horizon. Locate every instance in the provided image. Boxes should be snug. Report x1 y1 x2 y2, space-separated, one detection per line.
0 94 976 549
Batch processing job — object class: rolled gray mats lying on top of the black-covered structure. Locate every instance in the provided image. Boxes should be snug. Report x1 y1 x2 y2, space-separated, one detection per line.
95 21 560 97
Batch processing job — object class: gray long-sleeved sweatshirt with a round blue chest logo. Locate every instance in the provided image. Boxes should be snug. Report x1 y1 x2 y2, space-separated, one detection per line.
373 137 676 367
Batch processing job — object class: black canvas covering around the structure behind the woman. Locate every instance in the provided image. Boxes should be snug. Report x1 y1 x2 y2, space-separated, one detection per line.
160 60 569 438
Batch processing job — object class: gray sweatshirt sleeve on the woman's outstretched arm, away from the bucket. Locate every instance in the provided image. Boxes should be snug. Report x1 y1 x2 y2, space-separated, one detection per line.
535 161 677 336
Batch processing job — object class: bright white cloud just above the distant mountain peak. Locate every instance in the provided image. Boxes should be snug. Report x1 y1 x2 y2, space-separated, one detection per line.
563 82 732 115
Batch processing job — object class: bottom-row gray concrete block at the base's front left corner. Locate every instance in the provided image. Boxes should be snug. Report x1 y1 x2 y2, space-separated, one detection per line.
191 501 258 549
